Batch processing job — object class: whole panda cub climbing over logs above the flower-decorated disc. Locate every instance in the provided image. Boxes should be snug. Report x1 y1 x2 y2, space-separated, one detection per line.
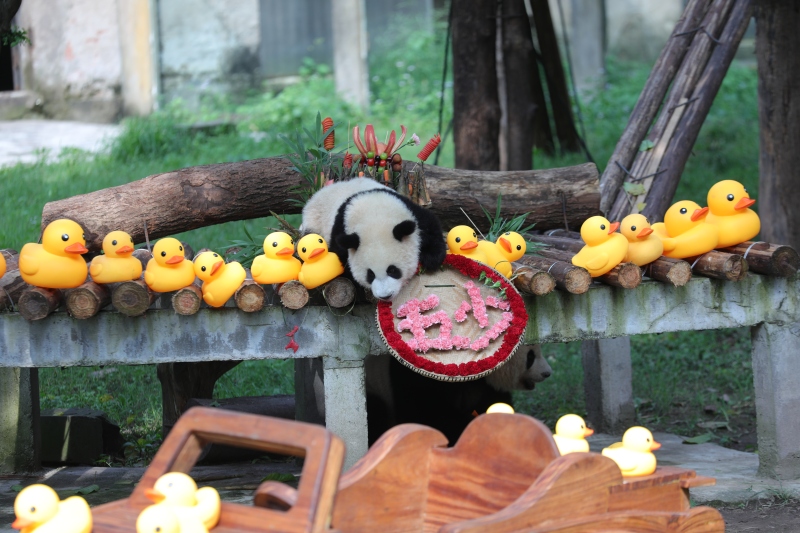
301 178 447 300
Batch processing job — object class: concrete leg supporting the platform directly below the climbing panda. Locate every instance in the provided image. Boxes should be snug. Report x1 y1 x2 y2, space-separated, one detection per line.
324 357 369 472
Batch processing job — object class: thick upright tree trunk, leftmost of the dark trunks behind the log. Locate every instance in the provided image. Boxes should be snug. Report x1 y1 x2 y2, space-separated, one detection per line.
452 0 500 170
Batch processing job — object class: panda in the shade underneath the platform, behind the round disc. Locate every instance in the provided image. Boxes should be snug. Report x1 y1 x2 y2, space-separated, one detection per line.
364 344 552 446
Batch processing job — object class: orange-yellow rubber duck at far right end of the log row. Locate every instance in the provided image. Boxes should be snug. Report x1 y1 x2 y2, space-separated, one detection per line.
706 180 761 247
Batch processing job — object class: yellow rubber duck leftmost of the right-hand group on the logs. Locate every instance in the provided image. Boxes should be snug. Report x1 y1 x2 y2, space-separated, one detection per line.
572 216 628 277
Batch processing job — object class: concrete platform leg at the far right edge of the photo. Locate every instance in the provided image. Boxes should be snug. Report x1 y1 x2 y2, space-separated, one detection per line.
750 322 800 479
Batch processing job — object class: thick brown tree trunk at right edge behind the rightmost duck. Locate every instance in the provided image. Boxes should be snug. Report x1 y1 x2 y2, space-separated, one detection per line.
756 0 800 249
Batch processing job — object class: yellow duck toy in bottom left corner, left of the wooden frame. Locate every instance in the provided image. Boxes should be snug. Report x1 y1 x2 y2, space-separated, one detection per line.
11 484 92 533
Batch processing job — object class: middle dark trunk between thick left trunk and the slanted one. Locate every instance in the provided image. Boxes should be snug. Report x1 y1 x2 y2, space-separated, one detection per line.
502 0 553 170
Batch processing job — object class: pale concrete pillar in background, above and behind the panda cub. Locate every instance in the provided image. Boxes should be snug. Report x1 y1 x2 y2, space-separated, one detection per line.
331 0 369 110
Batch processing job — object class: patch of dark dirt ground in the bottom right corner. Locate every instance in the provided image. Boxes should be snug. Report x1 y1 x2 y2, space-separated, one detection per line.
718 498 800 533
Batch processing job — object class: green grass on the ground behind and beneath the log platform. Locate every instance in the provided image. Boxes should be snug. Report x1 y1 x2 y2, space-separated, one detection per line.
10 25 758 461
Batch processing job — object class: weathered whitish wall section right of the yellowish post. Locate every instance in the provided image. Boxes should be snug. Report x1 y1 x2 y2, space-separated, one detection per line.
158 0 261 105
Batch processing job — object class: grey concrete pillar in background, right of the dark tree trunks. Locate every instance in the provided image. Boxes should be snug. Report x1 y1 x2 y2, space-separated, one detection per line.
568 0 606 92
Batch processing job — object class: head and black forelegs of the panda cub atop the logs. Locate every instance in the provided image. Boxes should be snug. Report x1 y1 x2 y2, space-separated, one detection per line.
334 189 446 300
